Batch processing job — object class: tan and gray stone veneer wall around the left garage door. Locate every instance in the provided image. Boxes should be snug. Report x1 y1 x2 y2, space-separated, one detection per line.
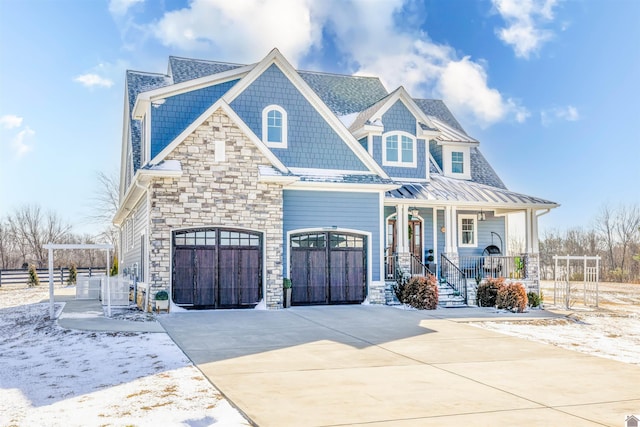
149 110 283 309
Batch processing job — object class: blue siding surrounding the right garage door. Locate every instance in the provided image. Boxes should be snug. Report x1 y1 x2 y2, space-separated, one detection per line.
283 190 382 281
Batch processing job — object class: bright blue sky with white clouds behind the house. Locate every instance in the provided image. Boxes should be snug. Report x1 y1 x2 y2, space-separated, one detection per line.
0 0 640 237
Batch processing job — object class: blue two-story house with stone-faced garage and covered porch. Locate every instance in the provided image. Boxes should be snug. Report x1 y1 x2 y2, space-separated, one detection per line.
113 49 558 309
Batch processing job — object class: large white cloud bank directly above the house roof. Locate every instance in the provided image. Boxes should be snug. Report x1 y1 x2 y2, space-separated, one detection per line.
149 0 529 127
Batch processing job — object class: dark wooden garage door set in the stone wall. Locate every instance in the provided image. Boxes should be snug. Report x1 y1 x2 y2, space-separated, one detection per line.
172 228 262 308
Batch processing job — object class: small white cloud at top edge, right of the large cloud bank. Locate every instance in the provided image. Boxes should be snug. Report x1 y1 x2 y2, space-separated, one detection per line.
493 0 558 59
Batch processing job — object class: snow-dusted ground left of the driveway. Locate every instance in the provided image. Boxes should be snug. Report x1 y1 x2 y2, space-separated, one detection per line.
0 287 249 427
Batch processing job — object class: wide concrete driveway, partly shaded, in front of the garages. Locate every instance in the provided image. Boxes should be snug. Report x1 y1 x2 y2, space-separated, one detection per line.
160 305 640 426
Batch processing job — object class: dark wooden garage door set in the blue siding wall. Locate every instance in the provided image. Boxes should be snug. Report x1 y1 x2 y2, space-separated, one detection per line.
290 232 367 305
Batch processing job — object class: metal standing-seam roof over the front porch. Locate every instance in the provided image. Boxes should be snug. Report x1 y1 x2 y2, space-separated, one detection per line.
385 175 559 209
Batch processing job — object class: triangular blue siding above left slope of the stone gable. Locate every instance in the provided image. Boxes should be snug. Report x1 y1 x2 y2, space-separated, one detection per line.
151 80 238 158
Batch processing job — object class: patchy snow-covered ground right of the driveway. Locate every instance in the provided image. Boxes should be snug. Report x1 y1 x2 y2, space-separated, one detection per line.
471 283 640 365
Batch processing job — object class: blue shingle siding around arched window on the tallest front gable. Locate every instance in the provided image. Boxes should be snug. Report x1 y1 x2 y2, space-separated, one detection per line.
231 65 368 171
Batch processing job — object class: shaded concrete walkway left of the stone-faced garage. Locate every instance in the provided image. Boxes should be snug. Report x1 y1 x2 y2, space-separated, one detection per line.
55 295 165 332
